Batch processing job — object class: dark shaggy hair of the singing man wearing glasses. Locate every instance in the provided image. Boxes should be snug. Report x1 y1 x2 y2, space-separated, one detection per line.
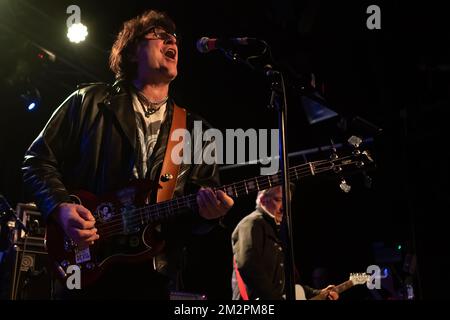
109 10 176 80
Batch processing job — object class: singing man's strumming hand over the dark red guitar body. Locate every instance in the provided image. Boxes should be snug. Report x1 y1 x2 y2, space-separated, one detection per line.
54 203 99 246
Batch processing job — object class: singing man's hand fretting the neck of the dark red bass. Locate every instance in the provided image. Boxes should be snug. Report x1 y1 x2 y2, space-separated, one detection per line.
197 188 234 220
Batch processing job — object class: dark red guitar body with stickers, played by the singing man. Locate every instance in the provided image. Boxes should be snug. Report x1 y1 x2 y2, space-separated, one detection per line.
46 180 164 287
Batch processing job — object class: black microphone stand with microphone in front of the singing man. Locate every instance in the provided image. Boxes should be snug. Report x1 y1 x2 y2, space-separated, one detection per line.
221 47 295 300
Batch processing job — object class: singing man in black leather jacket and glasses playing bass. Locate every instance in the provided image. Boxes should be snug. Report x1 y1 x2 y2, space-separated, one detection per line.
23 10 233 299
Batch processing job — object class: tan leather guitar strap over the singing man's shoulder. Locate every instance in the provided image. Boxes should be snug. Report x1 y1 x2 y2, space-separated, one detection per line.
156 103 186 202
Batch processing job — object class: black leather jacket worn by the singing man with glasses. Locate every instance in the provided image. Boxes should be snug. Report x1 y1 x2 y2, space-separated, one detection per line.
22 82 219 218
